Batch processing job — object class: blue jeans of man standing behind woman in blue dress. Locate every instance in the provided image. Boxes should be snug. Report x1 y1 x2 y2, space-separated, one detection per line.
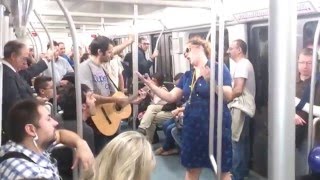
231 116 250 180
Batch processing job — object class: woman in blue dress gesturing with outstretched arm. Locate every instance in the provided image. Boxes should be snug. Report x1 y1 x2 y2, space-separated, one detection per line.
138 39 232 180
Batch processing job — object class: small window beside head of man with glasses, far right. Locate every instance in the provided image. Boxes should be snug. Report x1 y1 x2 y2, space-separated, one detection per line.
303 21 320 47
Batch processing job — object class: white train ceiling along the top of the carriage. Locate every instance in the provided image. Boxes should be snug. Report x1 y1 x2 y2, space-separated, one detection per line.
0 0 320 34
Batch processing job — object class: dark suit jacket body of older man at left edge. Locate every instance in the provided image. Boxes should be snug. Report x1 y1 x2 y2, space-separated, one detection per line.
2 64 33 143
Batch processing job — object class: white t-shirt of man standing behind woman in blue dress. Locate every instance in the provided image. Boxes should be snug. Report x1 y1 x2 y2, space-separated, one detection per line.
230 58 256 97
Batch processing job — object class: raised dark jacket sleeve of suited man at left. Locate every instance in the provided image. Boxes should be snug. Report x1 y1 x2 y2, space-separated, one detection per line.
19 60 48 86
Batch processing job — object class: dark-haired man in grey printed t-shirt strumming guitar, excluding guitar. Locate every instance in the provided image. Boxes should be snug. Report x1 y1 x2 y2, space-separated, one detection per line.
79 36 133 154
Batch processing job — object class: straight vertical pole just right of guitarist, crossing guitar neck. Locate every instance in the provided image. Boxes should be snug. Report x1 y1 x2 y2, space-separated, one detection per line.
132 4 139 130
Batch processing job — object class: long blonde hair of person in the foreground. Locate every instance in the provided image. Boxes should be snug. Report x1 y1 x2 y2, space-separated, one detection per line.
94 131 156 180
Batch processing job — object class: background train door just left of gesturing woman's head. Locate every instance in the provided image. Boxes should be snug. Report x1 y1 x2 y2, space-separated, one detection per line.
151 33 173 82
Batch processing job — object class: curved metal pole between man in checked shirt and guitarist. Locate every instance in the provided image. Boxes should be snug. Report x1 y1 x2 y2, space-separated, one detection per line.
57 0 83 179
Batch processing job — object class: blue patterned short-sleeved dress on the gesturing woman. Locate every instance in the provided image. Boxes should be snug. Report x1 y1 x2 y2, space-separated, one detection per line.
177 64 232 172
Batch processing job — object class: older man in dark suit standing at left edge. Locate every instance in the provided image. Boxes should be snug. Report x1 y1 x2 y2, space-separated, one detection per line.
2 41 47 143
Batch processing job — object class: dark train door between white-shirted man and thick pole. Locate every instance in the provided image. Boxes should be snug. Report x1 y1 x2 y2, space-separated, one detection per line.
248 25 268 177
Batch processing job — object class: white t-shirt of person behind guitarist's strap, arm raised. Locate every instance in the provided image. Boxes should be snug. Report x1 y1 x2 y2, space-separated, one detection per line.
103 55 123 88
